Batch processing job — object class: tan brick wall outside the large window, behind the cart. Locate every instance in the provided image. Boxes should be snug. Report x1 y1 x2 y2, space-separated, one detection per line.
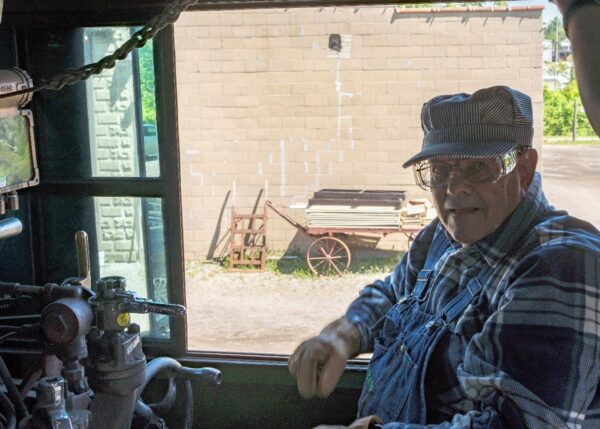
175 6 542 259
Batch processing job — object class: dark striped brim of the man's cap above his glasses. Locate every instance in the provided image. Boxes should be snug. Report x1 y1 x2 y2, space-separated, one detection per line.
402 142 517 168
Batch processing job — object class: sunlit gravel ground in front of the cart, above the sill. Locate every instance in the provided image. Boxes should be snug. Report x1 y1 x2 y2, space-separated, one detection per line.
186 264 376 354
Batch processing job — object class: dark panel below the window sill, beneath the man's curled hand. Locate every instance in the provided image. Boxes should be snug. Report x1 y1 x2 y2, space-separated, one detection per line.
147 358 366 429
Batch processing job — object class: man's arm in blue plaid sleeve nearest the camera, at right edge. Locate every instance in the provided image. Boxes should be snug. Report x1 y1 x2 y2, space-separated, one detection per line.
338 242 600 429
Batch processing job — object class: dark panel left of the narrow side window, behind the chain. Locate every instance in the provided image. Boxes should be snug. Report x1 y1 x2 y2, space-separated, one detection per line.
21 28 98 284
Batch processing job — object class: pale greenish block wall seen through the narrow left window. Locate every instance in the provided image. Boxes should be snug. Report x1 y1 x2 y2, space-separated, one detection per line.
84 28 141 262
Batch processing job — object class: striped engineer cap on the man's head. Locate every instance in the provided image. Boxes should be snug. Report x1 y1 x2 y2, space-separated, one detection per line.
402 86 533 168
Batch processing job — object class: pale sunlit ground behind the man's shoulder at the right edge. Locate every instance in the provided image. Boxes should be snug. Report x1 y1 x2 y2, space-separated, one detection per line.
539 145 600 229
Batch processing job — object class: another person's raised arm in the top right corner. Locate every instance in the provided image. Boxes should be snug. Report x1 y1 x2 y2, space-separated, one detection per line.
555 0 600 135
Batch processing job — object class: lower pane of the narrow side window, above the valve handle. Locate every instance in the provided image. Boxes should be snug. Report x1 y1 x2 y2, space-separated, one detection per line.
94 197 170 339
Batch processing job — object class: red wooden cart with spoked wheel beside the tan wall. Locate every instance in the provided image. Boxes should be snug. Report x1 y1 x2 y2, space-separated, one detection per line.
265 190 425 276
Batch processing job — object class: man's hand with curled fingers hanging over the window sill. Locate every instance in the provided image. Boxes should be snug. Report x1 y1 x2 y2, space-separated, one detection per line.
288 317 360 399
